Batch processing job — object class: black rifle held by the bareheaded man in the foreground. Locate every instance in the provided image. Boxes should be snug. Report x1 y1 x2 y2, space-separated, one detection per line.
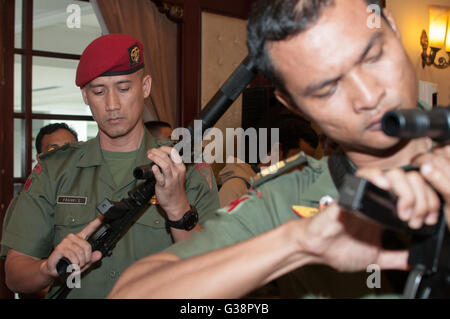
339 107 450 299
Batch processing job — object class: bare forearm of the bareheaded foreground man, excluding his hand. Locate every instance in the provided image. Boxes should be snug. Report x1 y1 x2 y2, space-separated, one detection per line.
109 222 308 298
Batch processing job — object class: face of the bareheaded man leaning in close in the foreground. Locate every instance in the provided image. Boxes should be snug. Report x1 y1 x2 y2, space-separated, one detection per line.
269 0 417 153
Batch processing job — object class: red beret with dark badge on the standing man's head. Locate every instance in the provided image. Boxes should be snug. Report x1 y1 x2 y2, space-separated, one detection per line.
75 33 144 87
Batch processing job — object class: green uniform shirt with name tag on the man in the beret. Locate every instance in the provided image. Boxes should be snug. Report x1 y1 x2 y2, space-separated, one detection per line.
1 130 219 298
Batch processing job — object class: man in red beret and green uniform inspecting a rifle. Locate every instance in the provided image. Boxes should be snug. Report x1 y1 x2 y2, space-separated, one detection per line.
1 34 219 298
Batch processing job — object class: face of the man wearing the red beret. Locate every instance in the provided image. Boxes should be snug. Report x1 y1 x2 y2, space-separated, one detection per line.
82 72 151 139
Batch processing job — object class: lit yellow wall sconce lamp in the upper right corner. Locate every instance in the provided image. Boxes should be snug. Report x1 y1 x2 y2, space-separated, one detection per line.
420 6 450 69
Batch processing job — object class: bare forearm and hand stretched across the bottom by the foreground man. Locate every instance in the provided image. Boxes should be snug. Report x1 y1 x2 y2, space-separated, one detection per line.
109 205 408 298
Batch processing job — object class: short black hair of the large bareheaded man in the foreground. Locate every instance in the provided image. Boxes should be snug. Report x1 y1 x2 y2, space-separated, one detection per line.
247 0 387 93
